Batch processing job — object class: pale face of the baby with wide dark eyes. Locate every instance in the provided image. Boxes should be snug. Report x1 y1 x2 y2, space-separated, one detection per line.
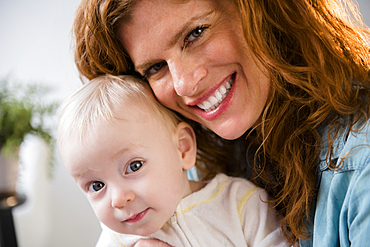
62 107 188 236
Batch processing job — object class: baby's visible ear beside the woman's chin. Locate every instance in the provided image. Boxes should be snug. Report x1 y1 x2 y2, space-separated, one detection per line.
176 122 197 170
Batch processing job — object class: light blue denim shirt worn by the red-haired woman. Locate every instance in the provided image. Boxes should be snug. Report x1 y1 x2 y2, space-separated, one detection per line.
300 118 370 247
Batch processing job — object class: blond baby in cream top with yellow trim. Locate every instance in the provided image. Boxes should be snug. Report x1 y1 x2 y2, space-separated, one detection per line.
58 75 289 247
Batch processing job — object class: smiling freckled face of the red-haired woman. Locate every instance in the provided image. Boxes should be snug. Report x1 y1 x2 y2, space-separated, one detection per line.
118 0 270 140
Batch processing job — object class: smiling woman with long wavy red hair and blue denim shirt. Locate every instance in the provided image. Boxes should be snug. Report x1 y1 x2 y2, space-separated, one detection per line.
74 0 370 246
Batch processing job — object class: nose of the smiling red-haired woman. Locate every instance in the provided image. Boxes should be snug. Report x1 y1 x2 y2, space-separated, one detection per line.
167 58 207 96
